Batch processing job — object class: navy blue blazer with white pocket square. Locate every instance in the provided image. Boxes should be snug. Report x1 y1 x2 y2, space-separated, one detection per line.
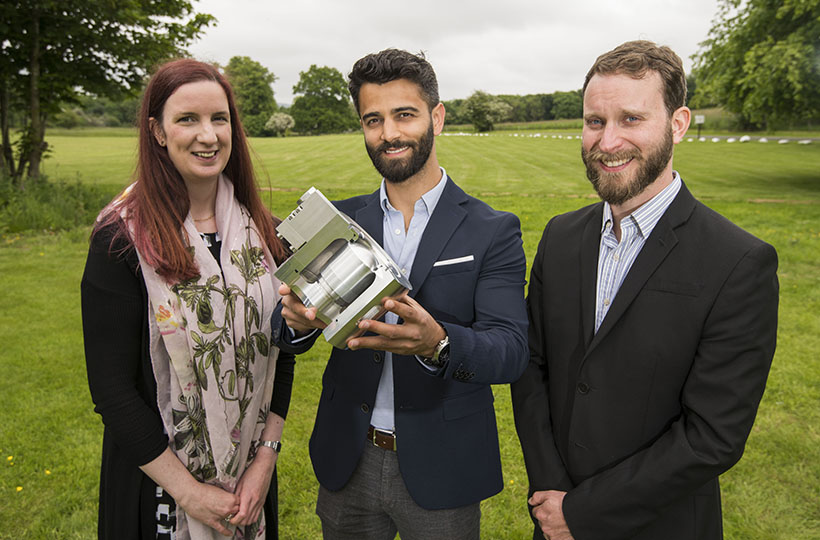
274 178 528 509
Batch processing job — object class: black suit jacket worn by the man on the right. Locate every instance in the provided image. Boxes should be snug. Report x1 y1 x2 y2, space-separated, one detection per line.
512 182 778 540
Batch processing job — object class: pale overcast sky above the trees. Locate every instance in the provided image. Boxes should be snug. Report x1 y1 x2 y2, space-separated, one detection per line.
190 0 717 104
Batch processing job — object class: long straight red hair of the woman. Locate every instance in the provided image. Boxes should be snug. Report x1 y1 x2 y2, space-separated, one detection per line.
97 58 287 281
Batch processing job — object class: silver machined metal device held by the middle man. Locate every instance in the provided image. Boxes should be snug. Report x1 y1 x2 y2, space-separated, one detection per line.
275 187 412 349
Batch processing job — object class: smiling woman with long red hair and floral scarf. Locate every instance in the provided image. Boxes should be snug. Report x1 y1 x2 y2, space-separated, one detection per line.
81 59 294 540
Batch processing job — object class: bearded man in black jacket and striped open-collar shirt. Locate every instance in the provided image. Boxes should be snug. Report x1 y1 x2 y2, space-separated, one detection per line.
512 41 778 540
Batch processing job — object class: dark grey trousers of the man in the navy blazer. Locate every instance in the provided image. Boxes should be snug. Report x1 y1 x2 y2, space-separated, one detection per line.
316 443 481 540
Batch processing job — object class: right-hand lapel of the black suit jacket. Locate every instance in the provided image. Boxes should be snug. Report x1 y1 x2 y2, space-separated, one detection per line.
587 185 695 354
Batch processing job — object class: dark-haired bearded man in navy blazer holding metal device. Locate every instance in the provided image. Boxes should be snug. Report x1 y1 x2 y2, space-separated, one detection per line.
274 49 527 540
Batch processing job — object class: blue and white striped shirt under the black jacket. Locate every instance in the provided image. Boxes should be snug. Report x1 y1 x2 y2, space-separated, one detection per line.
595 175 682 332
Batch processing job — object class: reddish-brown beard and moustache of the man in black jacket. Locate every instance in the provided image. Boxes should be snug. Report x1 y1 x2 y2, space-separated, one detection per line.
581 125 674 206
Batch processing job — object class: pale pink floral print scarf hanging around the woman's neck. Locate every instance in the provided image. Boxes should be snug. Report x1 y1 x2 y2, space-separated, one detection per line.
130 175 279 540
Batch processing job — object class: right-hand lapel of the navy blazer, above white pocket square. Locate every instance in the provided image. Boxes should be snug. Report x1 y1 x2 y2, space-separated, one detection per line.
410 176 467 296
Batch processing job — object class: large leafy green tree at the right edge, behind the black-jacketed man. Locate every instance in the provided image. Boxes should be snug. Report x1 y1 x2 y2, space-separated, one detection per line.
693 0 820 129
